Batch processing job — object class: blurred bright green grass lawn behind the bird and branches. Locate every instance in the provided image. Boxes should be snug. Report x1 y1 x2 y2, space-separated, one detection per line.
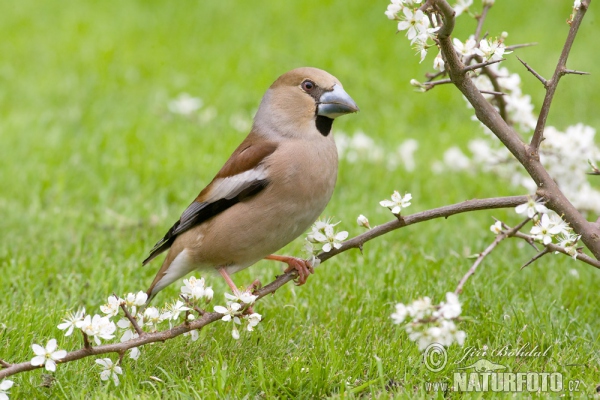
0 0 600 399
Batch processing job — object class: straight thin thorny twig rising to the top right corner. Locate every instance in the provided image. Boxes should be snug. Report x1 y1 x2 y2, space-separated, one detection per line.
530 0 592 152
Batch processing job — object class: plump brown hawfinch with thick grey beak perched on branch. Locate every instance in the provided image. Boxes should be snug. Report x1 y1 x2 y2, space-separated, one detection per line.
142 67 359 302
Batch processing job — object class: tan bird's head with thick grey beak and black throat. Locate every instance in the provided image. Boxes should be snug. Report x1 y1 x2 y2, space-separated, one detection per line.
254 67 359 138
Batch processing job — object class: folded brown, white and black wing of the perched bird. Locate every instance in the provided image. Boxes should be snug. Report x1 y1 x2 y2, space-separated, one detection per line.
142 138 277 265
